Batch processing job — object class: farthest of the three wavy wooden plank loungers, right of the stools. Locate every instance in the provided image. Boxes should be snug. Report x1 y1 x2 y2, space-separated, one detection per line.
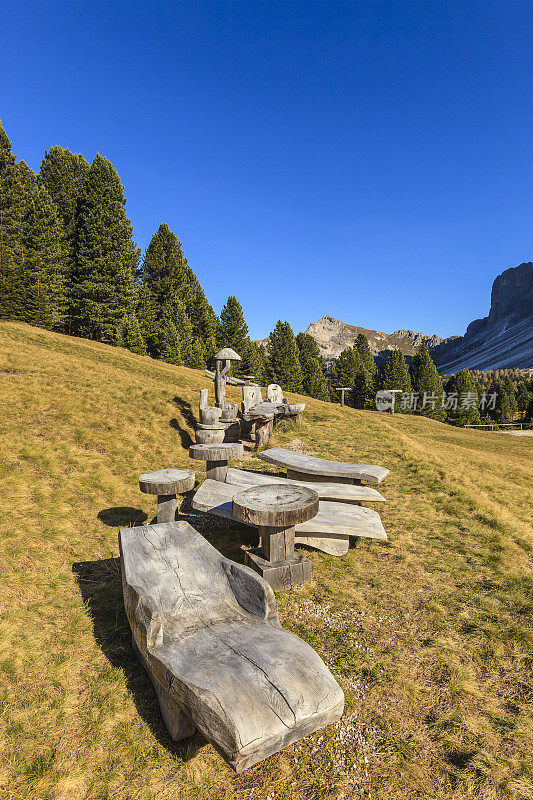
258 447 389 483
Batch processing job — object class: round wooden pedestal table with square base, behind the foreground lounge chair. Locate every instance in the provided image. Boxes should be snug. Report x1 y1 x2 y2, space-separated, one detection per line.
232 483 318 590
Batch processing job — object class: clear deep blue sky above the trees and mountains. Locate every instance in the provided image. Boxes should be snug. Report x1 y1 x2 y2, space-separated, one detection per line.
0 0 533 338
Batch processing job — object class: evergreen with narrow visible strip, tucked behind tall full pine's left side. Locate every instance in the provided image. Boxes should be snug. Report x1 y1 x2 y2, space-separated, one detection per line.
40 146 89 324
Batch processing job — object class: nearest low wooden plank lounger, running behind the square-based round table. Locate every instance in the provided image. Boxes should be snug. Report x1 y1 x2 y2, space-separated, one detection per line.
192 479 387 556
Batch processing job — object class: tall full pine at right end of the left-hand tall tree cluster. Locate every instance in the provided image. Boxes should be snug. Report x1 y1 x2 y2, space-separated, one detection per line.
72 154 139 342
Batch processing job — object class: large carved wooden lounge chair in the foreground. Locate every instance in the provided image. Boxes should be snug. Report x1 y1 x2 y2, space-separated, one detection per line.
119 520 344 772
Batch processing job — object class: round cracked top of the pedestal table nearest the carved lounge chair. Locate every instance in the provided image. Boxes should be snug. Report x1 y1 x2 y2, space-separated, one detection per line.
232 483 318 528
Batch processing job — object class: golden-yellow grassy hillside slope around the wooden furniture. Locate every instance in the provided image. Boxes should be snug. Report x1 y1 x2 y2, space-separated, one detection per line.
0 323 533 800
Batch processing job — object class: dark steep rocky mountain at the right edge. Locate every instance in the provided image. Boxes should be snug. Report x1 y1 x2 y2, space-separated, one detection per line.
431 261 533 375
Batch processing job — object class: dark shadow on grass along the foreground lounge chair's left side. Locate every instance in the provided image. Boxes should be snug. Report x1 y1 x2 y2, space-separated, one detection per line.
72 558 207 762
